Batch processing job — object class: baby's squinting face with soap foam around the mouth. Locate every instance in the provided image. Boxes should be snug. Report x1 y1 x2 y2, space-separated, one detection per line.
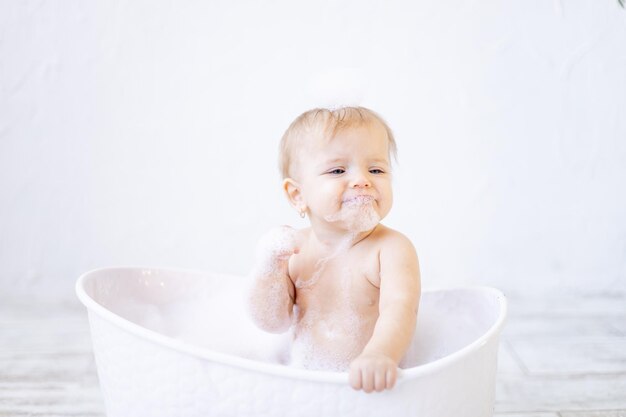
297 122 393 232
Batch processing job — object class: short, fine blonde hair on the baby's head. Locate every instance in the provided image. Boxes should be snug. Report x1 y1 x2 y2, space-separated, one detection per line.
278 107 397 178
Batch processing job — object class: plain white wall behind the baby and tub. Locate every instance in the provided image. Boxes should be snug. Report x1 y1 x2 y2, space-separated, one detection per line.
0 0 626 295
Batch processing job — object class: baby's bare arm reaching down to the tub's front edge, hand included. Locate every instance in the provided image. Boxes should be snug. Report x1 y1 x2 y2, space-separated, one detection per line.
350 234 420 392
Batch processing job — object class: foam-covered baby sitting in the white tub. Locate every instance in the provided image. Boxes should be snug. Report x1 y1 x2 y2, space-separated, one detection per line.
249 107 420 392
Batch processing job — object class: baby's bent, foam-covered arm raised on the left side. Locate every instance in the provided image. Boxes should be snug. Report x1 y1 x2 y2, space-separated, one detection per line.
249 226 298 333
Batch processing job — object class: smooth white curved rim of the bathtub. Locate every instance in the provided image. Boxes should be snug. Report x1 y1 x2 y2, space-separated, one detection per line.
75 266 508 385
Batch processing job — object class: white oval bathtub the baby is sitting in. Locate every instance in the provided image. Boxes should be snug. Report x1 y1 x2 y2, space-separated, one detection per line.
76 268 506 417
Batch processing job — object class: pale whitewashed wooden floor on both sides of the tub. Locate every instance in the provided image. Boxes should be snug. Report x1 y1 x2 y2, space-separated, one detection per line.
0 294 626 417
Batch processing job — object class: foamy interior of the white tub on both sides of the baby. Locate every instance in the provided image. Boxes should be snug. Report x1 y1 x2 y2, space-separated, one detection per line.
85 269 498 368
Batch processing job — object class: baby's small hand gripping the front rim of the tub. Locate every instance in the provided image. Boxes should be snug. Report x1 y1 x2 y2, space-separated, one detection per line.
350 353 398 393
